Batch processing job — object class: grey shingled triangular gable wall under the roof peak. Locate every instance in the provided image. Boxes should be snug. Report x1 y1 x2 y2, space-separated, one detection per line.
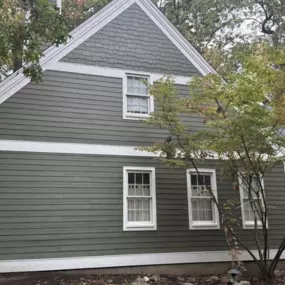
62 4 199 76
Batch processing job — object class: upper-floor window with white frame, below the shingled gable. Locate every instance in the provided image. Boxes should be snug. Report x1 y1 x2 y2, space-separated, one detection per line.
124 74 153 118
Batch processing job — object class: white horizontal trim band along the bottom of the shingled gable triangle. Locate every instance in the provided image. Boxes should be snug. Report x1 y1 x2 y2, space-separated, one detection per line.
47 62 191 85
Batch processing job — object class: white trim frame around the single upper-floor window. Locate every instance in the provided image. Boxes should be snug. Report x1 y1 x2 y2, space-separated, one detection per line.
123 73 154 120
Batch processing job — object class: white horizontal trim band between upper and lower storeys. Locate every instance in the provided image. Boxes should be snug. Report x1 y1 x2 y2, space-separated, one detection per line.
0 140 155 157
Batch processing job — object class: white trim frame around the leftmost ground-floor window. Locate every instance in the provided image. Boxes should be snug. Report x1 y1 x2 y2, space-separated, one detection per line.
123 166 157 231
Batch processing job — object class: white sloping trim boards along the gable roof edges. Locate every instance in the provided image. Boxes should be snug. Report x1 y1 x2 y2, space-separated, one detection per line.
0 0 216 104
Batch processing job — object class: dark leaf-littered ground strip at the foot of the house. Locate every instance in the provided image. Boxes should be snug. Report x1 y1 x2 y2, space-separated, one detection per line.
0 272 285 285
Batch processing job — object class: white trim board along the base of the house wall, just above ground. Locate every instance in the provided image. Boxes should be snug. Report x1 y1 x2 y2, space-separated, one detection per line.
0 250 285 273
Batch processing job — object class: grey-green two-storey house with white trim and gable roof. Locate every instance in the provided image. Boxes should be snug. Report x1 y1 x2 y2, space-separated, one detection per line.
0 0 285 272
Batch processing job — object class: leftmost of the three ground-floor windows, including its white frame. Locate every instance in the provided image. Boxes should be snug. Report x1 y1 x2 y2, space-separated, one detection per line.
124 167 156 231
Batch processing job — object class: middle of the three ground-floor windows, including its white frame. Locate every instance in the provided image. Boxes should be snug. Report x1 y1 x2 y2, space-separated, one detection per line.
187 169 220 229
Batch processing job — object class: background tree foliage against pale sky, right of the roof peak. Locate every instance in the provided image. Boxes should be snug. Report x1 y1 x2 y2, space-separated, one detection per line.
156 0 285 53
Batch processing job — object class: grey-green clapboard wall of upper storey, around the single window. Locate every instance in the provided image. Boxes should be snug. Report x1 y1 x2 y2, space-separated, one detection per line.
0 71 203 146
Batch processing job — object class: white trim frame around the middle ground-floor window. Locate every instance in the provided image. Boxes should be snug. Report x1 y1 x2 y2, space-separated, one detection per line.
186 168 220 230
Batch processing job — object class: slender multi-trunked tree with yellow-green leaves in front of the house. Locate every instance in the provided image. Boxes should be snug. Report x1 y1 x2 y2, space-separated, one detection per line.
140 45 285 282
